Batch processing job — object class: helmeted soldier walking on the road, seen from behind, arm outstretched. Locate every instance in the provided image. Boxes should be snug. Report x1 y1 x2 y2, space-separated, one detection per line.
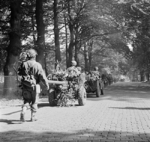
18 49 49 122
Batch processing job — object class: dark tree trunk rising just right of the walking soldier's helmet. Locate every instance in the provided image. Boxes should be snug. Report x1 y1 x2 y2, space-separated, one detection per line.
35 0 46 69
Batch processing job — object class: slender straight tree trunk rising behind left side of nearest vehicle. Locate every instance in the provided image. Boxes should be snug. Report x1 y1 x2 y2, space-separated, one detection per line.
53 0 61 62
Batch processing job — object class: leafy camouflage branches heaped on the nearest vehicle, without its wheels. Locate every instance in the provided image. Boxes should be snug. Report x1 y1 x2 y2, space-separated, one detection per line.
48 68 81 106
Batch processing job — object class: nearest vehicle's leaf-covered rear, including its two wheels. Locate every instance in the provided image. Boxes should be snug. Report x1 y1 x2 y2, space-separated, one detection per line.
48 67 86 106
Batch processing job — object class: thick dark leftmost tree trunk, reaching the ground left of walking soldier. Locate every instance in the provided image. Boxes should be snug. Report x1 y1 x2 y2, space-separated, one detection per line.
3 0 22 96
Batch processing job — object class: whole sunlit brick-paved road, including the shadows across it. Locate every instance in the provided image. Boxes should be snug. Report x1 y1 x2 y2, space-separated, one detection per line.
0 83 150 142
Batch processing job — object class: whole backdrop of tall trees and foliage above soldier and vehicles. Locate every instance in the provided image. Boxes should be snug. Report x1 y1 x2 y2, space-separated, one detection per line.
0 0 150 93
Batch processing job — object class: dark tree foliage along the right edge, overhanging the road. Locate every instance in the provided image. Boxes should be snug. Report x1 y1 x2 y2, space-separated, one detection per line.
117 0 150 81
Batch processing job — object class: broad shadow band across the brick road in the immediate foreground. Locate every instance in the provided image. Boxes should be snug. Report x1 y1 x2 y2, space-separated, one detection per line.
0 129 150 142
